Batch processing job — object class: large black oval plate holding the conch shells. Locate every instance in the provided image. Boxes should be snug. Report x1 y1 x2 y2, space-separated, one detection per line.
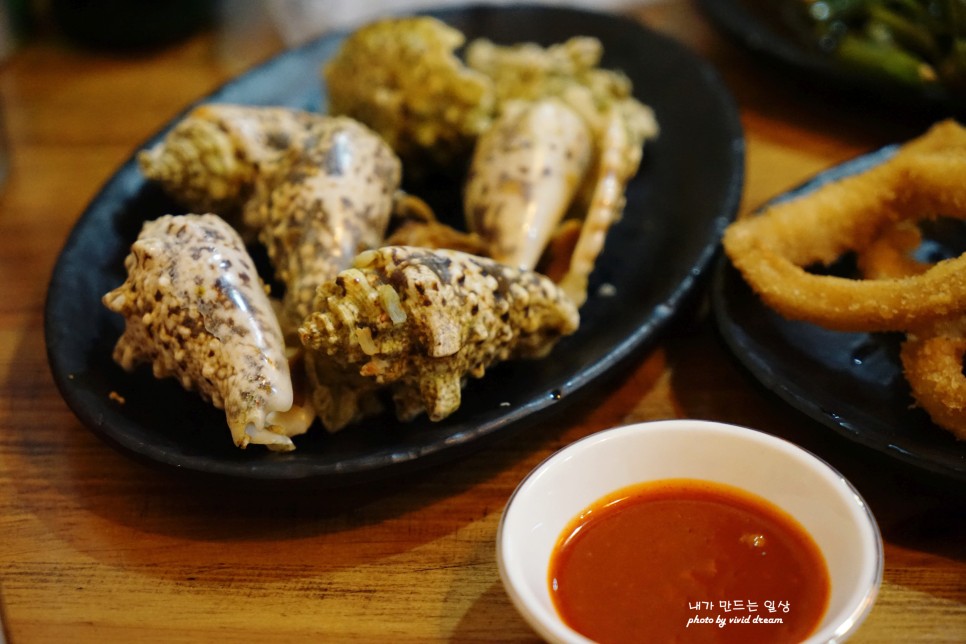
45 6 744 485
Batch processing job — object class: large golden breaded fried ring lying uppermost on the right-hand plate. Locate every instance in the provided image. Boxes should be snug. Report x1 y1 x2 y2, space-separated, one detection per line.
723 121 966 332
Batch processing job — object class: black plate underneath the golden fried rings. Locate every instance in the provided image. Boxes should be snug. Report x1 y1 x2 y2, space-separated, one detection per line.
711 146 966 480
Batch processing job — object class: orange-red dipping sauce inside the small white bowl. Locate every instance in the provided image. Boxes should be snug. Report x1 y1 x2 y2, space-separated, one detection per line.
549 479 830 642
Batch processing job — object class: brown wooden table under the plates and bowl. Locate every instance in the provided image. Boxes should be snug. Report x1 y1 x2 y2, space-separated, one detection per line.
0 2 966 644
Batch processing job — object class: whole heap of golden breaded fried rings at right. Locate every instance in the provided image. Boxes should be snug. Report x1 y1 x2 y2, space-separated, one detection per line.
723 120 966 439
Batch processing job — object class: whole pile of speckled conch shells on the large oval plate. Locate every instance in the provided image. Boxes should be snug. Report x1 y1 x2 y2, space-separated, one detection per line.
103 17 658 450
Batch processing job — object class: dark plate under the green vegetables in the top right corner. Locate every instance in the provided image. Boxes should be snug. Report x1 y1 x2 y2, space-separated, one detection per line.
698 0 966 116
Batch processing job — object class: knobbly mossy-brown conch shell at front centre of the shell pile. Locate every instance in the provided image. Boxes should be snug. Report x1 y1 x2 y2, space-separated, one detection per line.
299 246 579 431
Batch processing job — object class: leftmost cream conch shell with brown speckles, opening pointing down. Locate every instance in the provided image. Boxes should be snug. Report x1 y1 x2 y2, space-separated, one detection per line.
102 214 314 451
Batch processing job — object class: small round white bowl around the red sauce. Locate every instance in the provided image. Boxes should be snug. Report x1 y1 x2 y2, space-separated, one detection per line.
497 420 883 642
